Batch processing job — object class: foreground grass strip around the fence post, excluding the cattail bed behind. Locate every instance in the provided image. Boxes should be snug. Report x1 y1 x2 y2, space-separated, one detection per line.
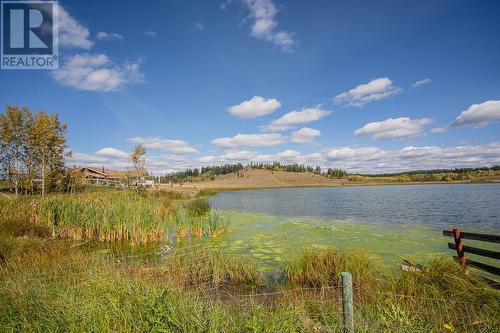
0 235 500 332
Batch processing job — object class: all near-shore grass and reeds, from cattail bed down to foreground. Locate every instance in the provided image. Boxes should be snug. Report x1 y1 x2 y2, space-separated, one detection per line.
0 188 500 332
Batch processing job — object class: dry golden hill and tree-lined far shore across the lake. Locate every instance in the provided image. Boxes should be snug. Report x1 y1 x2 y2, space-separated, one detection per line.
156 165 500 195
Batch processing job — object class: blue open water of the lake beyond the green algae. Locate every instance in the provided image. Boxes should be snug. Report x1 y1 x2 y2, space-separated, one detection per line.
212 184 500 231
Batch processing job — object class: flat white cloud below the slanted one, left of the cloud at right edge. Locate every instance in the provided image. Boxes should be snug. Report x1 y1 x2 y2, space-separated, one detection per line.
354 117 433 140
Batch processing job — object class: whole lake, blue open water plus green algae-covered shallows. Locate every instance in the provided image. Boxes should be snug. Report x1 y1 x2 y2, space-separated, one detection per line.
211 184 500 267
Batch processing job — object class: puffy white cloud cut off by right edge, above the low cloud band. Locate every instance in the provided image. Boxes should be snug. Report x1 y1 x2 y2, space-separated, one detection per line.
451 100 500 127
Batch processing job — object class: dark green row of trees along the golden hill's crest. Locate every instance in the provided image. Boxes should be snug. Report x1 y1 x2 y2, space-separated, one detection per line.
160 162 348 183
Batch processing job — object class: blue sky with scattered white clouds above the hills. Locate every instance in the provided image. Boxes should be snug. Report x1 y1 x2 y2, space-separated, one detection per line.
0 0 500 174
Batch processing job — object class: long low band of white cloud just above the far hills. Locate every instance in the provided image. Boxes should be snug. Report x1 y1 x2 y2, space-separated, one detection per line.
174 142 500 173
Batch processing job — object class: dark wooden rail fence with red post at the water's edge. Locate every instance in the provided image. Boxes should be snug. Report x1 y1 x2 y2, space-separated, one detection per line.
443 229 500 276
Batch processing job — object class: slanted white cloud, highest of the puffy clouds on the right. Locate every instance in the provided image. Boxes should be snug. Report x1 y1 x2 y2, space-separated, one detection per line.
333 77 401 107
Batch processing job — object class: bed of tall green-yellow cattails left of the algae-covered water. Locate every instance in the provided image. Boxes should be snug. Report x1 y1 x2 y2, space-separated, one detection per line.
0 189 225 243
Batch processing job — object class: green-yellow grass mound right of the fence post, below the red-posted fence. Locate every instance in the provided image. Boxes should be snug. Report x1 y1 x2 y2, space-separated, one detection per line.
355 258 500 332
